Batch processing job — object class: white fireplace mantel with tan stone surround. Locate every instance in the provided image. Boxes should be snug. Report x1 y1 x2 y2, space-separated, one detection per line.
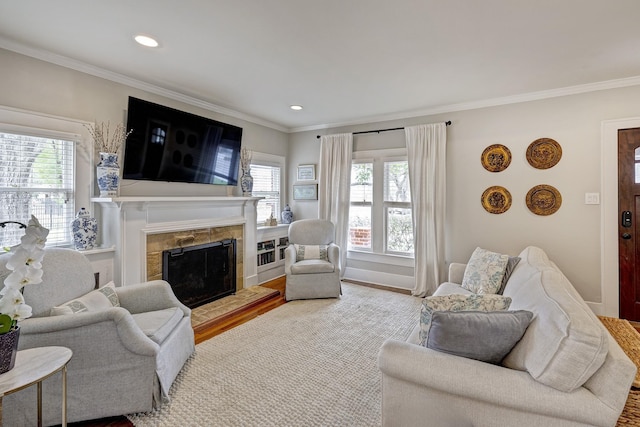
91 196 260 289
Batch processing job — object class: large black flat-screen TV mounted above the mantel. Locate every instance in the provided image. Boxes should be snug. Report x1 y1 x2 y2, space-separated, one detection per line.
122 97 242 185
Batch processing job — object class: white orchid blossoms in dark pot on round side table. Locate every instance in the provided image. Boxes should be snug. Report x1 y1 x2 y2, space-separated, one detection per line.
0 215 49 334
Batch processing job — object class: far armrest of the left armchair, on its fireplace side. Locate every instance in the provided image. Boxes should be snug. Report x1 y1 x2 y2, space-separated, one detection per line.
116 280 191 317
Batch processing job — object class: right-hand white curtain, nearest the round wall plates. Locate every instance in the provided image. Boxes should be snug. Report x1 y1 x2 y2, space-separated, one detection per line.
405 123 447 297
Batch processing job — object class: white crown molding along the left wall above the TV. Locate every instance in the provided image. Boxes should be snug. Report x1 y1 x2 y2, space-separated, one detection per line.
0 37 291 133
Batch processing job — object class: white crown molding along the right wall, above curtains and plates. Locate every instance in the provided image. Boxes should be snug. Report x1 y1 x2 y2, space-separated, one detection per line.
289 76 640 133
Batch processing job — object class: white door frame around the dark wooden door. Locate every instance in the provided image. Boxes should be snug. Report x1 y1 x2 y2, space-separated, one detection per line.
599 117 640 317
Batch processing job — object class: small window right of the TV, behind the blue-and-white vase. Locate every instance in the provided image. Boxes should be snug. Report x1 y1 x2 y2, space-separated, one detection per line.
251 152 284 225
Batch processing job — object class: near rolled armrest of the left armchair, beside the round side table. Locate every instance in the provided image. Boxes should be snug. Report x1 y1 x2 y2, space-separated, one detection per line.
19 307 160 358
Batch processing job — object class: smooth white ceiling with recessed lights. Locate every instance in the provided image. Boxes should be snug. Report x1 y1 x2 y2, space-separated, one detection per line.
0 0 640 131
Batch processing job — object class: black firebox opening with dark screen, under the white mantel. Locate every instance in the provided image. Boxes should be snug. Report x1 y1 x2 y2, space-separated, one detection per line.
162 239 236 308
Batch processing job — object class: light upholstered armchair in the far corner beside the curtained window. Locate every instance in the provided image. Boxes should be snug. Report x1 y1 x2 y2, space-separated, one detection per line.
284 219 342 301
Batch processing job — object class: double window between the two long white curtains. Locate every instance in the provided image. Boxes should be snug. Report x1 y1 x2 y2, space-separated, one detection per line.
349 150 413 256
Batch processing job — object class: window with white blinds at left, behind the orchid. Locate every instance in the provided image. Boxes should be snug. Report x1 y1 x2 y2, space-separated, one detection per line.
0 131 75 246
